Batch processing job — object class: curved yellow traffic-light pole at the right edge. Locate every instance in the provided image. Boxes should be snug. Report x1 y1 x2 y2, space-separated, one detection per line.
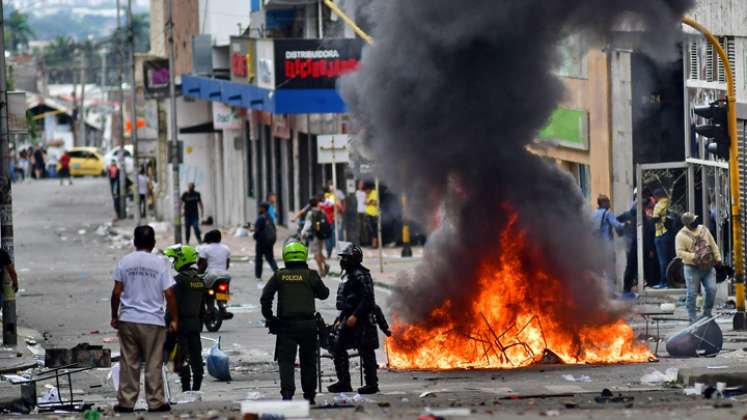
682 16 746 324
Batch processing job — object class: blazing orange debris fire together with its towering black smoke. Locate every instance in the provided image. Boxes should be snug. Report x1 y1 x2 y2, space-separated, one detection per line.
342 0 692 368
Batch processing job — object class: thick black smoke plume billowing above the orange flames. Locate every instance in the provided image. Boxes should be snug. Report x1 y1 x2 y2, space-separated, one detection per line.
342 0 692 325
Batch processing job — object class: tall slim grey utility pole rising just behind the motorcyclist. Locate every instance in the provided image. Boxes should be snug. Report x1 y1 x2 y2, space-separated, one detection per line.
166 0 182 244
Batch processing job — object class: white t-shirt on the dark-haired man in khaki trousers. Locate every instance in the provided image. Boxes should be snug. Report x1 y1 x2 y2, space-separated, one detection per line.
112 251 174 327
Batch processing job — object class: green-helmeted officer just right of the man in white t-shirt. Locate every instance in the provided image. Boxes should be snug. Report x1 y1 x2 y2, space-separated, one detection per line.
164 245 207 392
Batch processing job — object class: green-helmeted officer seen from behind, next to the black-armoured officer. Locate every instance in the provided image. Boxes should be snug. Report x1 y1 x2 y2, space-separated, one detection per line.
260 242 329 404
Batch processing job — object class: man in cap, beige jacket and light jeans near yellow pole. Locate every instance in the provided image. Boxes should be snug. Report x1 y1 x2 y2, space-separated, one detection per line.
675 212 722 323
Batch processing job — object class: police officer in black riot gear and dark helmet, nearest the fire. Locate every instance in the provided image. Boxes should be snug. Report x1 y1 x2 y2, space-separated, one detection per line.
327 244 380 394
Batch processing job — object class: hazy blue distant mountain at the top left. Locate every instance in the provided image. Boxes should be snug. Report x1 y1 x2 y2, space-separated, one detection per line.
4 0 149 41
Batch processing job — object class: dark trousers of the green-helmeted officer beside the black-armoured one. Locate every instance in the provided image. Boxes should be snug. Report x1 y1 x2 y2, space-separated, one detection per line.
277 319 317 398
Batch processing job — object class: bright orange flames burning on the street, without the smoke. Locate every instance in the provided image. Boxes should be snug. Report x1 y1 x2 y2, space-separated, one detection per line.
386 217 654 369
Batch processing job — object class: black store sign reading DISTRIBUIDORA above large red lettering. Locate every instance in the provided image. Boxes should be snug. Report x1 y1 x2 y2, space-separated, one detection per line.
274 39 362 89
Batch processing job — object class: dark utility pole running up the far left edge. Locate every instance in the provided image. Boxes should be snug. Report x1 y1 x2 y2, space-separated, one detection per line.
0 0 18 346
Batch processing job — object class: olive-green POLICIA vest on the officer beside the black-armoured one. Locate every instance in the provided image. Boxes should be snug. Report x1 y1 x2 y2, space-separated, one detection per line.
275 268 316 320
